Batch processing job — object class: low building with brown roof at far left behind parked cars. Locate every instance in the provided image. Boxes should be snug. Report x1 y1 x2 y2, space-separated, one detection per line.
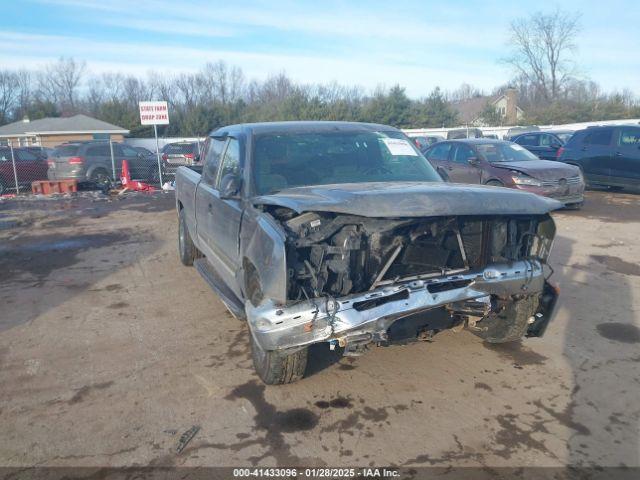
0 115 129 147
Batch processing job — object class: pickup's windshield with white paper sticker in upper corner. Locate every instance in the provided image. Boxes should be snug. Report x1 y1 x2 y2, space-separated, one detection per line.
254 131 442 195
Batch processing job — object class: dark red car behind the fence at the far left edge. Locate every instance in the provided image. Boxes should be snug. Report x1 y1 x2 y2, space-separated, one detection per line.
0 147 48 195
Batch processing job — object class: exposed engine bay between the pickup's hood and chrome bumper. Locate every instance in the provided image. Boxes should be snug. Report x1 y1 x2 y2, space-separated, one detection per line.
273 209 550 301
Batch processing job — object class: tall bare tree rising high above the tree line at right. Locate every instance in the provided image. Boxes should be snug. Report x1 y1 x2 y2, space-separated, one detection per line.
505 9 580 101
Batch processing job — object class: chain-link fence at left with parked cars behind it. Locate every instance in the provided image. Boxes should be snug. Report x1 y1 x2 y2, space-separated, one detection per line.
0 135 202 195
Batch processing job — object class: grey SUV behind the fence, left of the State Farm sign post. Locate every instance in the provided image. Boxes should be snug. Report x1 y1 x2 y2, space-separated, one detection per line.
47 141 158 187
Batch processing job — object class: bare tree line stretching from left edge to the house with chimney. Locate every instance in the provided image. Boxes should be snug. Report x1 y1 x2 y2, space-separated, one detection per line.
0 58 457 136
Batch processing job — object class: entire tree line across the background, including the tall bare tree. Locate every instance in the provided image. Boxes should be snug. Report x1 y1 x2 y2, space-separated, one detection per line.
0 9 640 136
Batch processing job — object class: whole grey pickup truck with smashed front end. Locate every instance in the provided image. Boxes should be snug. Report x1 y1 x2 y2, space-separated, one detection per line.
176 122 561 384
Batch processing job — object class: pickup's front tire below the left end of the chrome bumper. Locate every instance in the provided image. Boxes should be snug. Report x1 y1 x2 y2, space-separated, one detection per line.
250 334 309 385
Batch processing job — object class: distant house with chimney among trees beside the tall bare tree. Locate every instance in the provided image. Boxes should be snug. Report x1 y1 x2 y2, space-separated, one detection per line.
451 88 523 127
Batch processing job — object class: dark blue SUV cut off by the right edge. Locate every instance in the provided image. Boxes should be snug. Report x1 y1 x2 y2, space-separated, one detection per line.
558 126 640 190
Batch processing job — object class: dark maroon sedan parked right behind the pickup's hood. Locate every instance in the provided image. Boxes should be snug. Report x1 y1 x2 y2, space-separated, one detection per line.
424 138 584 208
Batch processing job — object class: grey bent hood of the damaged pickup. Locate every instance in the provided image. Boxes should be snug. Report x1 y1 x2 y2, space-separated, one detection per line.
253 181 562 218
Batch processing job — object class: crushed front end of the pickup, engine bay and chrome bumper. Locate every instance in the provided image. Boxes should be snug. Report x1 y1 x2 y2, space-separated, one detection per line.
245 208 557 355
